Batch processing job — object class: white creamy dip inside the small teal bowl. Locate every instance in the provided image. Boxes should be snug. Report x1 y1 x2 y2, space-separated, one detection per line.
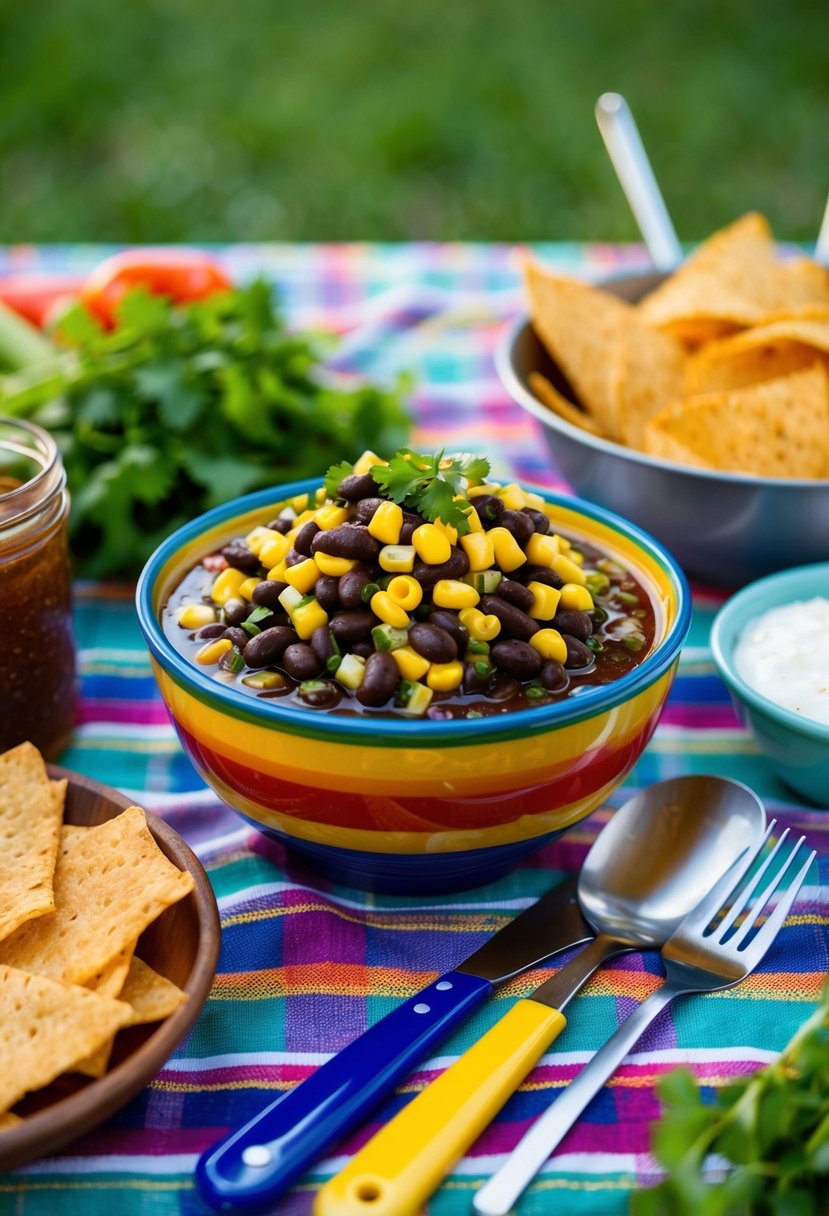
734 596 829 726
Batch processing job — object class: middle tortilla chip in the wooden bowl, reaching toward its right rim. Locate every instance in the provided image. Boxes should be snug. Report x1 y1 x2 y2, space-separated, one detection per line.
0 806 193 984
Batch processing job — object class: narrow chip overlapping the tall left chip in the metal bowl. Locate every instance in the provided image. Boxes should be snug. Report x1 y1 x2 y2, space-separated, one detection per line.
610 322 688 447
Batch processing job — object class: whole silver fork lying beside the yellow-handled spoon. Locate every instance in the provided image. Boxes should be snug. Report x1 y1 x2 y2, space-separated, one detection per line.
473 820 816 1216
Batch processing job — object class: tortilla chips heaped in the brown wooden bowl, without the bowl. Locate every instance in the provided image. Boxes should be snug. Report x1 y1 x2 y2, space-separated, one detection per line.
0 743 193 1128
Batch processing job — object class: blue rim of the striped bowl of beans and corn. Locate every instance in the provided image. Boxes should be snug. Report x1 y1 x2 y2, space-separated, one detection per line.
135 478 692 747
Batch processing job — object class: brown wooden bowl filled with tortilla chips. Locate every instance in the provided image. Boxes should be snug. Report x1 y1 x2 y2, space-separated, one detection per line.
0 743 219 1171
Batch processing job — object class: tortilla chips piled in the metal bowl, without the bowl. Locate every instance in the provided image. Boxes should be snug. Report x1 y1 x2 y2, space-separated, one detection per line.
525 214 829 479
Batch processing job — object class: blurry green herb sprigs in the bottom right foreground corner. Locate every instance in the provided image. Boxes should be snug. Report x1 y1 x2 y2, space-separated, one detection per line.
632 984 829 1216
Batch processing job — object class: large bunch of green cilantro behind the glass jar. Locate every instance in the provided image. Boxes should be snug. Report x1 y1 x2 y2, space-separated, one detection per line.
0 282 408 578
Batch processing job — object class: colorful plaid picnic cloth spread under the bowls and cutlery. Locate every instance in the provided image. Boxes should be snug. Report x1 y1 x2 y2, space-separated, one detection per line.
0 244 829 1216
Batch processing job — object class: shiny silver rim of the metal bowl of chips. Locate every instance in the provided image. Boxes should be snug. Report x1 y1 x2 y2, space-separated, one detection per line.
495 314 829 497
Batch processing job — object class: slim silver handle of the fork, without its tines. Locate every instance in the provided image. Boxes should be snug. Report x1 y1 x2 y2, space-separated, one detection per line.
473 984 681 1216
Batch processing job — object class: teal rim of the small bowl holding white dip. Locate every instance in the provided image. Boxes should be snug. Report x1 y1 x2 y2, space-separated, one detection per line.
711 562 829 744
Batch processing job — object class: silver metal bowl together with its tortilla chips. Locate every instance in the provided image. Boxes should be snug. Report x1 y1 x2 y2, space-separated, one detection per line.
496 214 829 587
